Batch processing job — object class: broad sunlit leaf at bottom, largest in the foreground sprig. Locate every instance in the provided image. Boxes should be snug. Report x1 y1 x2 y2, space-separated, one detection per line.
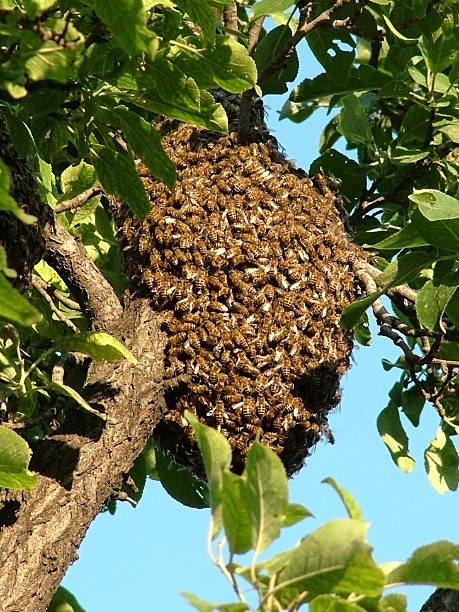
276 519 384 605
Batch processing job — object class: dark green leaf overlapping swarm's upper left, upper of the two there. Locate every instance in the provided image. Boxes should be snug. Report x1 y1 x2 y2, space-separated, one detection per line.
116 108 176 189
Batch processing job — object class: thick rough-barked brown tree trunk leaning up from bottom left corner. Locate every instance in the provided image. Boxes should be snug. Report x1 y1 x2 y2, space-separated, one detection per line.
0 300 163 612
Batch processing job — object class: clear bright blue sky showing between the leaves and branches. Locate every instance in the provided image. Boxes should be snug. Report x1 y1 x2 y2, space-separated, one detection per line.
63 45 459 612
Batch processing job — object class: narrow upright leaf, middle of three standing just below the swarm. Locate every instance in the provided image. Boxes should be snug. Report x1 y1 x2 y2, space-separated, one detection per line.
222 470 252 554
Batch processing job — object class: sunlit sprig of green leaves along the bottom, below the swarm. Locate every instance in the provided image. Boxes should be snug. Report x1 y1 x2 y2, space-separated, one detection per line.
184 414 459 612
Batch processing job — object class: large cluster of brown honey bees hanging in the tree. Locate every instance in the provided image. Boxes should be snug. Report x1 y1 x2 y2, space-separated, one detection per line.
110 99 360 474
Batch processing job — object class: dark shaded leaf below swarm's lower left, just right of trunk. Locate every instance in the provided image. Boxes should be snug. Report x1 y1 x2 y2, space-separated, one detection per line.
155 446 209 508
